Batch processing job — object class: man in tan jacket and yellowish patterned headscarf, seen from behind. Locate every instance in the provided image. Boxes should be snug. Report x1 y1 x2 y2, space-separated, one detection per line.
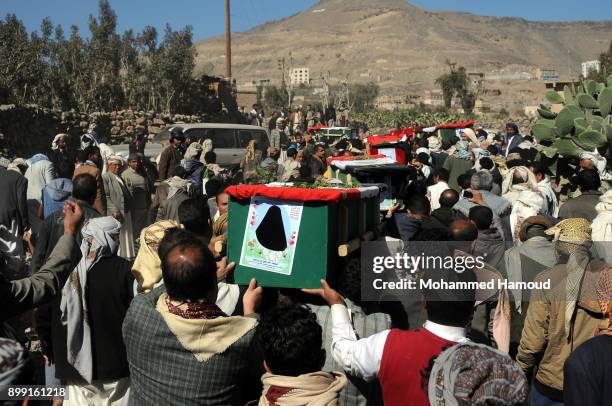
516 218 611 405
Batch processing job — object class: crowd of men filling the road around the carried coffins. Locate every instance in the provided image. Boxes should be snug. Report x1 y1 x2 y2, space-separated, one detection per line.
0 120 612 405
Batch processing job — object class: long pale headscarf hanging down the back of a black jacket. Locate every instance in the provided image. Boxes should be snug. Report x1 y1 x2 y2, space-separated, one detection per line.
60 216 121 383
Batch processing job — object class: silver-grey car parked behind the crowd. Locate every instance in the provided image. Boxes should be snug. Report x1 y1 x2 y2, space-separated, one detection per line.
112 123 270 168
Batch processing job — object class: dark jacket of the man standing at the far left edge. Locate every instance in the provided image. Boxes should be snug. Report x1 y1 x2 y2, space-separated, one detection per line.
0 167 30 234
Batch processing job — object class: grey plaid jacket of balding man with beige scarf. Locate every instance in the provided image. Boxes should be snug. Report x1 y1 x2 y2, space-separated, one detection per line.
123 286 254 406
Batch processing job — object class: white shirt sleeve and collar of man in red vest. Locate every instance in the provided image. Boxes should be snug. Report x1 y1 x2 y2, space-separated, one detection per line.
331 304 468 381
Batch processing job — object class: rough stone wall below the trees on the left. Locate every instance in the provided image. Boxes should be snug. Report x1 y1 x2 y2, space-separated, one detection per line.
0 104 220 159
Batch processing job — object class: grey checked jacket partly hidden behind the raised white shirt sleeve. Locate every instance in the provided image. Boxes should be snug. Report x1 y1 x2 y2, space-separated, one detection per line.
308 299 391 406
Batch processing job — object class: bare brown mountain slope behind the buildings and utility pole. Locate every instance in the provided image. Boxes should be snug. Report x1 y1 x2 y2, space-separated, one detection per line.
196 0 612 106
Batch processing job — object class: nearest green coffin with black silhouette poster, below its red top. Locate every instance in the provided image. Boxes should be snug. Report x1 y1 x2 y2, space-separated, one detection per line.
227 184 380 288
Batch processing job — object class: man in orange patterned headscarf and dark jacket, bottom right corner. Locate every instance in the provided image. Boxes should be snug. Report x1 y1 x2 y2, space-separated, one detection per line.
563 271 612 406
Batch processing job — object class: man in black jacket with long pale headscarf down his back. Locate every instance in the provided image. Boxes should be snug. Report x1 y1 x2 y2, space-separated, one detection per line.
54 216 134 405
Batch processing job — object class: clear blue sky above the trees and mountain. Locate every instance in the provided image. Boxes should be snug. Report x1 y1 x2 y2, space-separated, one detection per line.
0 0 612 40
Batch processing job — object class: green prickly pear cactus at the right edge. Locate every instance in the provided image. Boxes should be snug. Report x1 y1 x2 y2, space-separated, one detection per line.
532 70 612 157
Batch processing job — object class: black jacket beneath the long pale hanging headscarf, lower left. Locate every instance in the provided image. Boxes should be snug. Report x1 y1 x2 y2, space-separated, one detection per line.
37 256 134 381
